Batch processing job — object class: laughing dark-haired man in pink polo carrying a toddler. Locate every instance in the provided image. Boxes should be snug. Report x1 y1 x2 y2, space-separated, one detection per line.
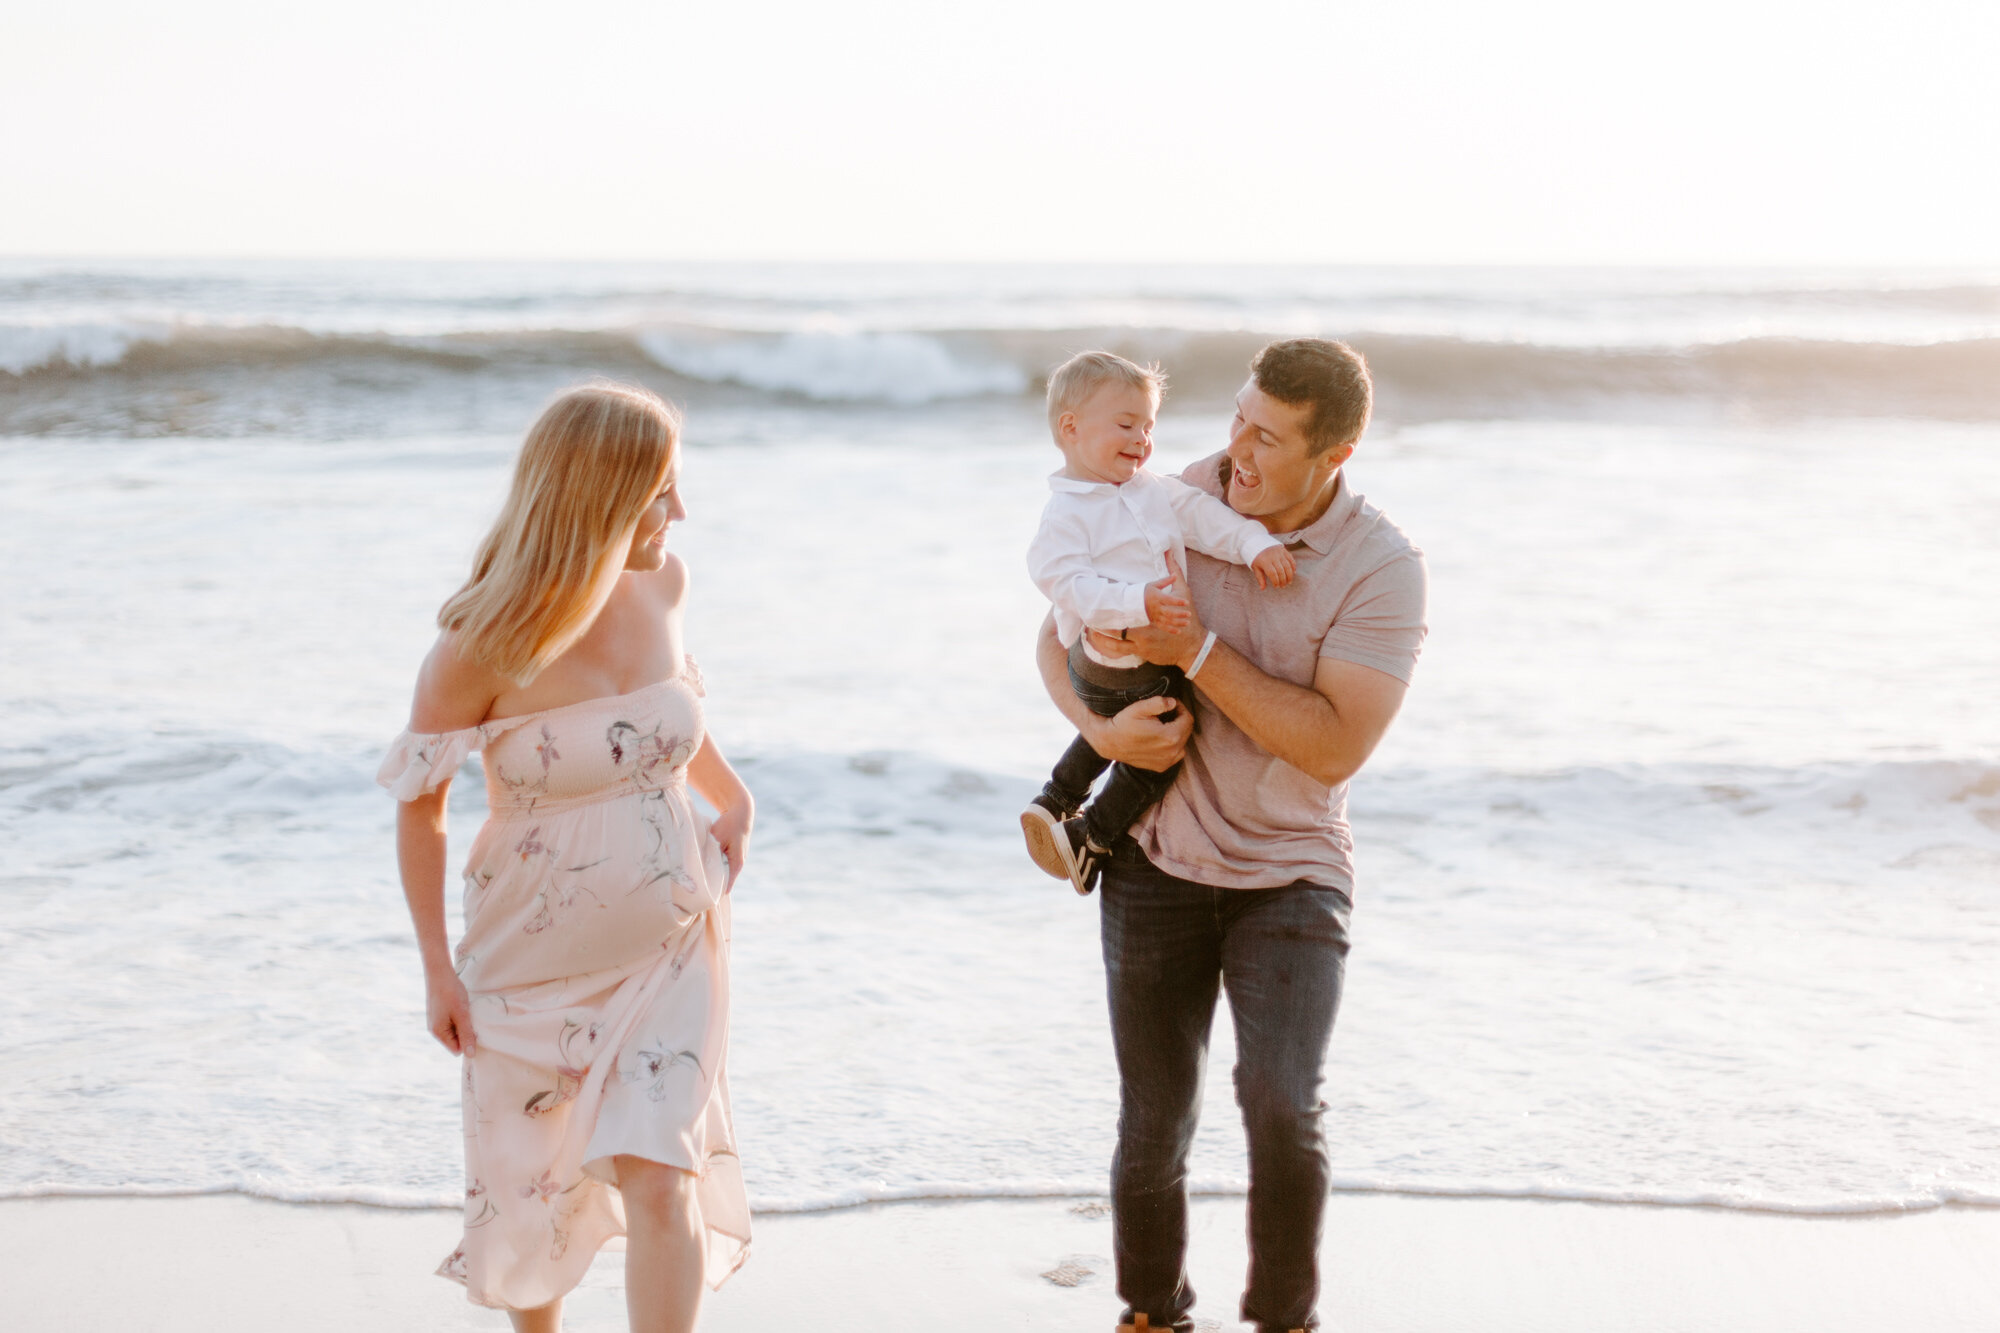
1036 338 1426 1333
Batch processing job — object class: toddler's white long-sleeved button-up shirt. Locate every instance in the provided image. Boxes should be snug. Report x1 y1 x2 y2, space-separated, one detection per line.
1028 468 1280 667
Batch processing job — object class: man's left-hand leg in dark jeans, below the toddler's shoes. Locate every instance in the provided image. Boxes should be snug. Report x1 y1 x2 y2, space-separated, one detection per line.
1100 839 1228 1329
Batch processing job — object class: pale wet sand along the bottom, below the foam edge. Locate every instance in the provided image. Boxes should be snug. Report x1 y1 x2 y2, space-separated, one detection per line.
15 1195 2000 1333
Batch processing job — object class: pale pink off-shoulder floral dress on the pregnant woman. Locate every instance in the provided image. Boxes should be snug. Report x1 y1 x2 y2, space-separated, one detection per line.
376 658 750 1309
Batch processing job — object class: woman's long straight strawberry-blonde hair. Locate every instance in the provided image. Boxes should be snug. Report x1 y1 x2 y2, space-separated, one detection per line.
438 380 680 685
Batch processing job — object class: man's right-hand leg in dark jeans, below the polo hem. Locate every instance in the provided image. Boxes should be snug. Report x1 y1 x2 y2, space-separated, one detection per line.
1222 885 1348 1331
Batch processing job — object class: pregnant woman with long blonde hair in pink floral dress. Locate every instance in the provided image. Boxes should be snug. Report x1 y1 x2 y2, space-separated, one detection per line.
378 382 754 1333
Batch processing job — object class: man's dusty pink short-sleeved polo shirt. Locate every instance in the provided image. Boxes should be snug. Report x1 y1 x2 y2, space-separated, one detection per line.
1132 454 1426 897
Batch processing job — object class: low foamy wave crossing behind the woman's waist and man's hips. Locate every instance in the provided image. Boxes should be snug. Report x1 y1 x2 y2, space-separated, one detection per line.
15 725 2000 860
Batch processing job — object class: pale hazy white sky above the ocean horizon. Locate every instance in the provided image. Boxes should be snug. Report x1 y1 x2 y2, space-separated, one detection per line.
0 0 2000 264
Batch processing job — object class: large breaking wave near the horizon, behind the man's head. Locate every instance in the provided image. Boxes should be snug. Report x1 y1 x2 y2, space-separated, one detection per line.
11 324 2000 420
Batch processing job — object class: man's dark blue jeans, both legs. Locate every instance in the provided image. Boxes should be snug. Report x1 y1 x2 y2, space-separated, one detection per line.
1098 839 1350 1329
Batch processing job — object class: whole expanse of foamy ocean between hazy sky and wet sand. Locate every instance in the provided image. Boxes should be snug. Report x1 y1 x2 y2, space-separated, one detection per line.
0 262 2000 1211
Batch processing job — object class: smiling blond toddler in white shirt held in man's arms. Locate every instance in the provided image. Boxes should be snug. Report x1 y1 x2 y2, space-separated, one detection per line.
1020 352 1296 893
